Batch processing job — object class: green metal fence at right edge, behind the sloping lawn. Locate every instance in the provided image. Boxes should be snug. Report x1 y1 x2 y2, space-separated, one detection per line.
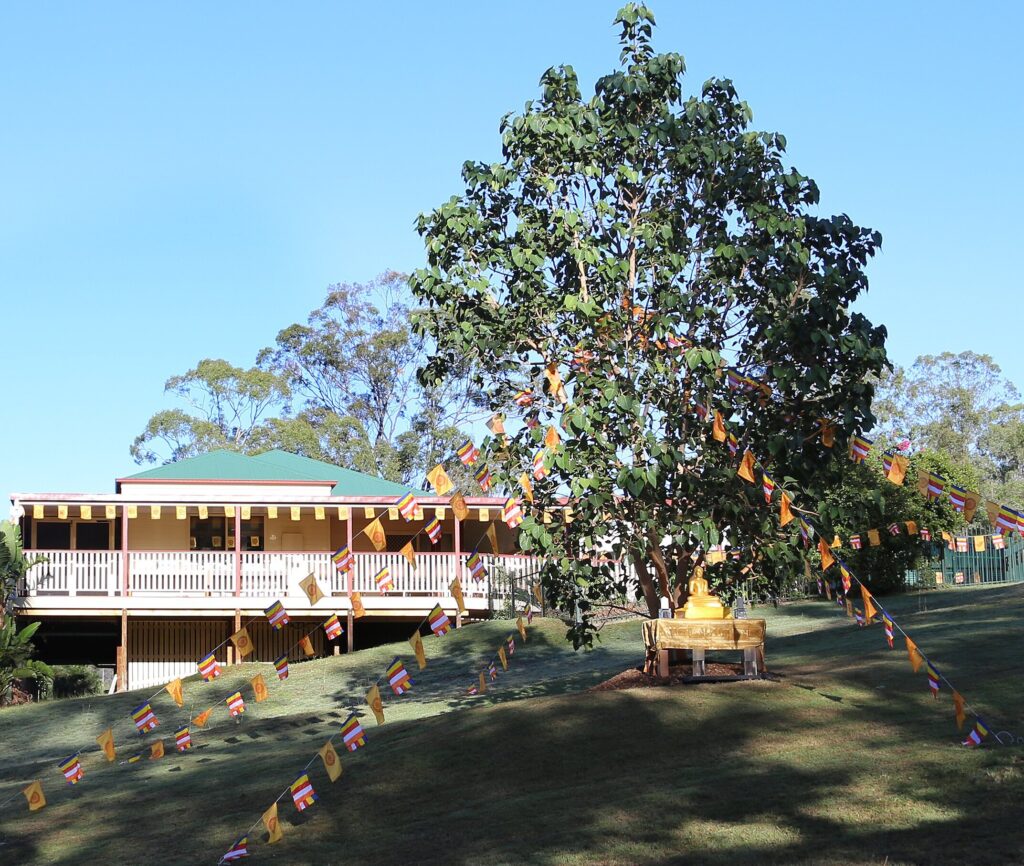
906 524 1024 587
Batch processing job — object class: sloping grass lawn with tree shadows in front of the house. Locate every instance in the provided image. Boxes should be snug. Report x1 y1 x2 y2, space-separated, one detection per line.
0 588 1024 866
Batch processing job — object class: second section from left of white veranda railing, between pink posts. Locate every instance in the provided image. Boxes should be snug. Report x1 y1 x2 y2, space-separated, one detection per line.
128 551 234 596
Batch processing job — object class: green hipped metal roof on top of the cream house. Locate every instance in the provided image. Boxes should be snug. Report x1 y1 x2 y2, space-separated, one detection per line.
123 450 430 496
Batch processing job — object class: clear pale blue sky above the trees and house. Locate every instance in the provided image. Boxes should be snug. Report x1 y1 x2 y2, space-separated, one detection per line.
0 0 1024 497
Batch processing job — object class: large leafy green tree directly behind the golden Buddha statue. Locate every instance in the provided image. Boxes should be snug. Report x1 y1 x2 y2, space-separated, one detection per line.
412 4 887 646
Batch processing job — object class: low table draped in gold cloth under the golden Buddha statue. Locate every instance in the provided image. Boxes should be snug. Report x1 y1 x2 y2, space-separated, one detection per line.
642 619 765 678
